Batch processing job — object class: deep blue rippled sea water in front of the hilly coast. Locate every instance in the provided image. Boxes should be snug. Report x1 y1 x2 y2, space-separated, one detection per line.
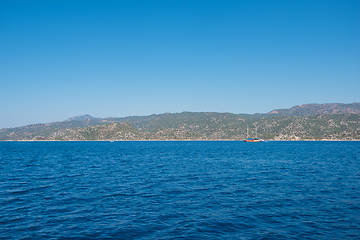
0 142 360 239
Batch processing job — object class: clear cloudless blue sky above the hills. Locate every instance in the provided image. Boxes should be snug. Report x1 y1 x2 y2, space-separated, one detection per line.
0 0 360 129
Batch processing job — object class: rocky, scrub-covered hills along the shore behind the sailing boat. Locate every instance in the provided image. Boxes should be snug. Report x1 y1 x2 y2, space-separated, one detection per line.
0 103 360 140
